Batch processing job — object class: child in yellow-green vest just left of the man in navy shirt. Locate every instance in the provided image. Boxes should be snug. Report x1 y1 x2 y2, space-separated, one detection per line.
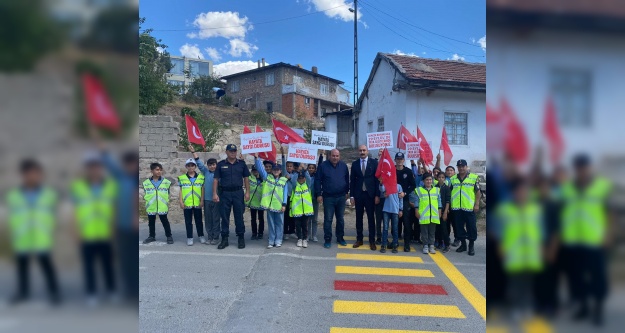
289 172 314 248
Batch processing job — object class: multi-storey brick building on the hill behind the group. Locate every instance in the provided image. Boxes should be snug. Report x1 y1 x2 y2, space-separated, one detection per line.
222 59 352 119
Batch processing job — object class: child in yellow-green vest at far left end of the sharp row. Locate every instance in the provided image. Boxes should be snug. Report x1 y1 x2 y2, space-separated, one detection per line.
143 163 174 244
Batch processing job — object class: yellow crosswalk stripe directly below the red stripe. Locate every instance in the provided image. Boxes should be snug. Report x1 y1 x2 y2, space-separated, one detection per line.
333 301 466 318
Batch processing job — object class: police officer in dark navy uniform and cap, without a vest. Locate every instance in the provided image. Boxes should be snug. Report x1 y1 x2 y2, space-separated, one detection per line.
213 144 250 250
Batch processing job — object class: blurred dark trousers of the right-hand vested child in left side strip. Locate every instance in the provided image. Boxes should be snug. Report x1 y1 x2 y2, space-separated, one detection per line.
81 243 114 296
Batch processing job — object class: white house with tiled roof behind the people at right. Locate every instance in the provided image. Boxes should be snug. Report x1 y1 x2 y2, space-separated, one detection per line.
338 53 486 165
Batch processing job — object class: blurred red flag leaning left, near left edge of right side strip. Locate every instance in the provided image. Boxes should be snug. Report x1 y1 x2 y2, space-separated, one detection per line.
499 97 529 163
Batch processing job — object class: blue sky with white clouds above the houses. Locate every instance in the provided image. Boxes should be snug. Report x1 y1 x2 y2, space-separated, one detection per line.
140 0 486 101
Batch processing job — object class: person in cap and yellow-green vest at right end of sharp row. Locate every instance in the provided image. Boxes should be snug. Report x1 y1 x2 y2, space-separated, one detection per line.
450 160 481 256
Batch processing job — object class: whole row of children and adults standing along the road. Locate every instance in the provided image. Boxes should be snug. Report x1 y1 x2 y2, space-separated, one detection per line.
143 144 481 255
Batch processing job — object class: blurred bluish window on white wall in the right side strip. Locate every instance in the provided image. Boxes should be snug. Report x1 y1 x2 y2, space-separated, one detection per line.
551 69 592 127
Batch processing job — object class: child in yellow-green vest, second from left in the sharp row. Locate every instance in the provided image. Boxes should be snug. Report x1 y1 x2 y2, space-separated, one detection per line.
178 158 206 246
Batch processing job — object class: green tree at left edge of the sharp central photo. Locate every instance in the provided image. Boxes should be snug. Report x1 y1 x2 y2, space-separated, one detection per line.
139 18 174 114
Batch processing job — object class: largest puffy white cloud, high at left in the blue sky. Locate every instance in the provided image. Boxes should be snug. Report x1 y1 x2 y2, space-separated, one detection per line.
187 12 253 39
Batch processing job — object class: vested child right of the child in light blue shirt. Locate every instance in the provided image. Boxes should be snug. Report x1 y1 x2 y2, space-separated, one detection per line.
410 173 442 254
